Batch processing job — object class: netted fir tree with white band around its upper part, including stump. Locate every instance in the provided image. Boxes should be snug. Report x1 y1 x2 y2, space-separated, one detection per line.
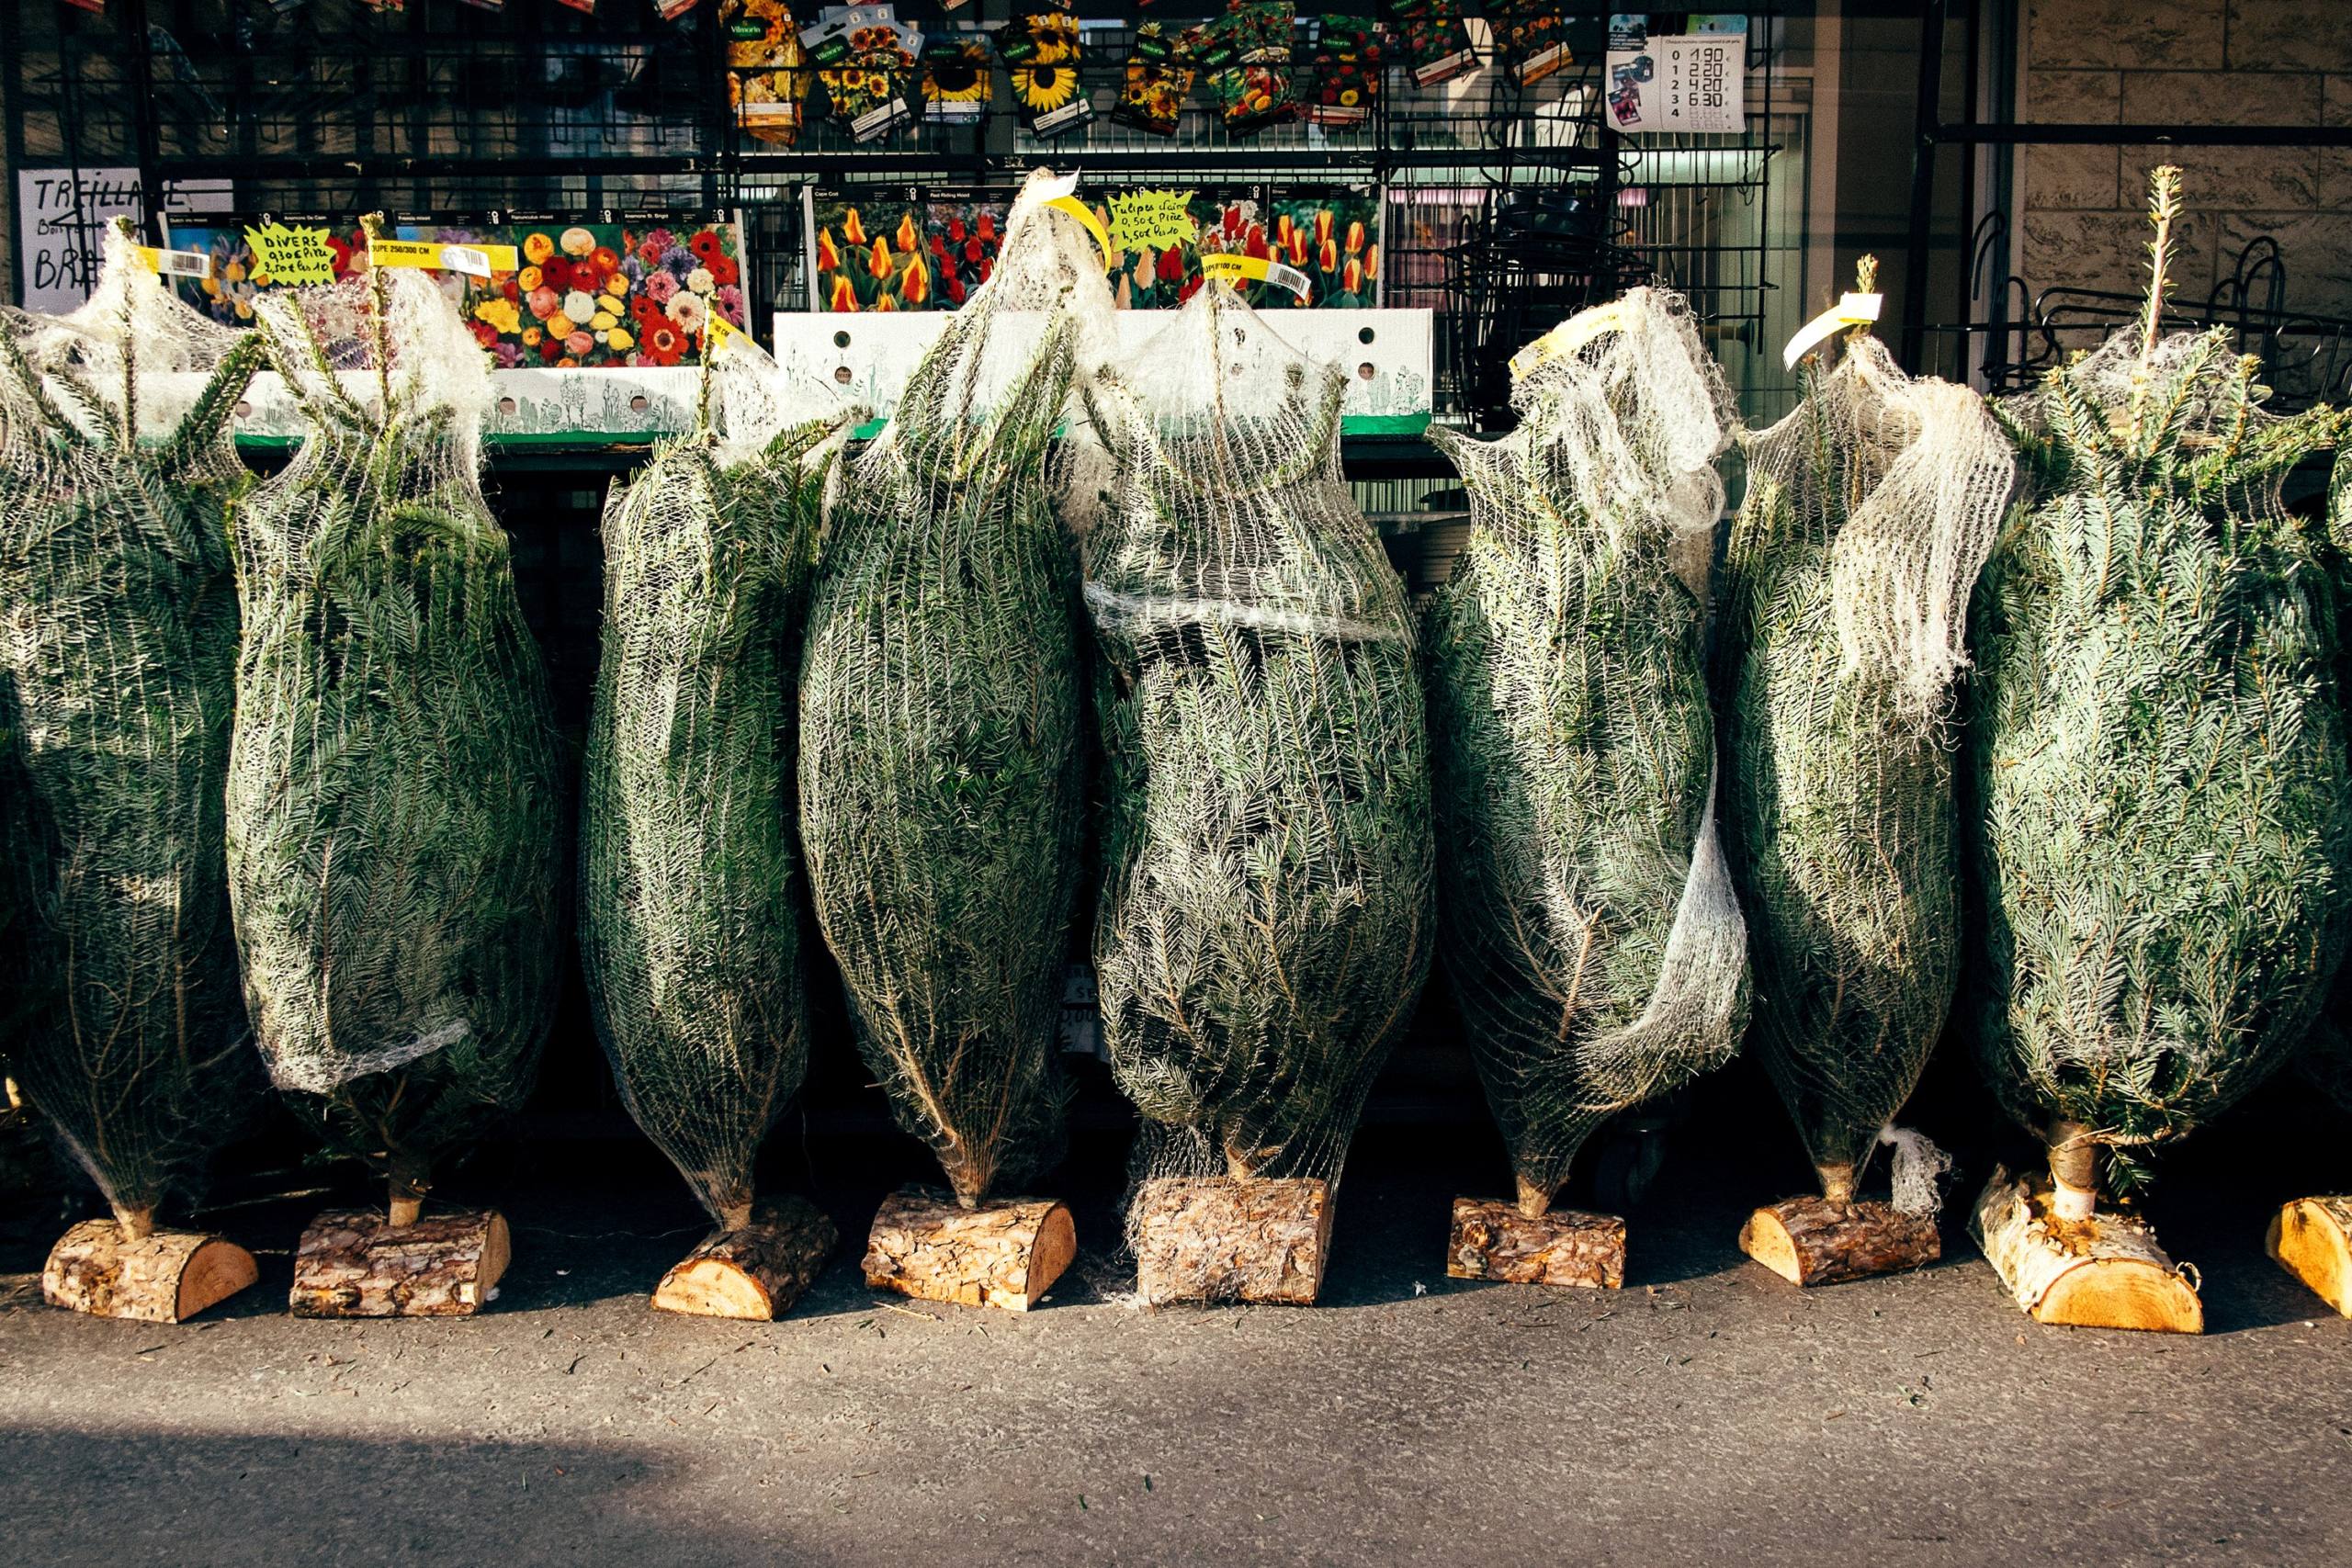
1084 282 1435 1304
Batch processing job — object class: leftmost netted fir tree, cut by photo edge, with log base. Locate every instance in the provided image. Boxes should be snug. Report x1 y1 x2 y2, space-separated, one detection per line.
0 221 264 1324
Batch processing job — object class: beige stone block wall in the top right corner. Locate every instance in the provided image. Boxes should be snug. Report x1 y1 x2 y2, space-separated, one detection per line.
2016 0 2352 315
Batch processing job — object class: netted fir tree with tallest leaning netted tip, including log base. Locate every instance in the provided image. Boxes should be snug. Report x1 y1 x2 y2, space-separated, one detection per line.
799 172 1110 1307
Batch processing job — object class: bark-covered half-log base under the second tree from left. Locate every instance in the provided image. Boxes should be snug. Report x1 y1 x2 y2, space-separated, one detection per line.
287 1208 513 1316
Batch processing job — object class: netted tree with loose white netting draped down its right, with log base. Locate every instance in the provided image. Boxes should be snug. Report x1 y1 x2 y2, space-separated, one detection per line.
1724 261 2016 1283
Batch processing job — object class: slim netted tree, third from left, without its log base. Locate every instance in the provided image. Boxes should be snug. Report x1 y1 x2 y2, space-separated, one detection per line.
581 339 864 1227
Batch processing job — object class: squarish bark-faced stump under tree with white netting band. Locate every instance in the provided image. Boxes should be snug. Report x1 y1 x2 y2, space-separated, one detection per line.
1126 1176 1331 1307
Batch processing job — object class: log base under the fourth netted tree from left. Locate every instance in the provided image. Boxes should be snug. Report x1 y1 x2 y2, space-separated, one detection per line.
864 1187 1077 1312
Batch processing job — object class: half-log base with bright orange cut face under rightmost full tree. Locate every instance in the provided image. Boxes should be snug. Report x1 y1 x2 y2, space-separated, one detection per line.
1971 1166 2204 1333
